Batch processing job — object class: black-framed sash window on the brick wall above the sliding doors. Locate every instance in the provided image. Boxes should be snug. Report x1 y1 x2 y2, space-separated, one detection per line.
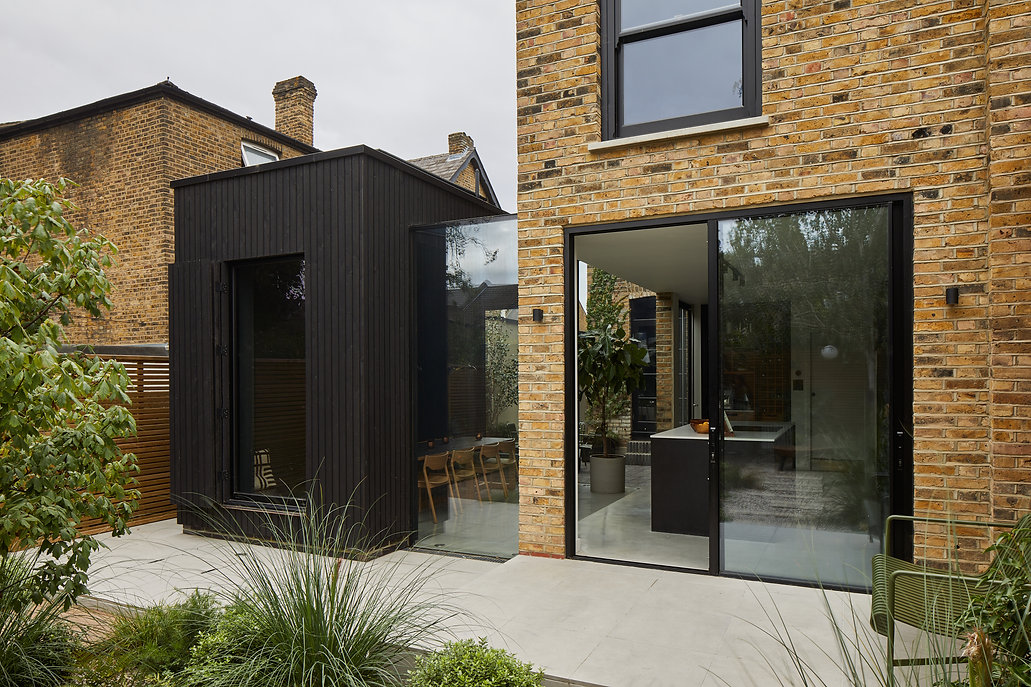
602 0 760 138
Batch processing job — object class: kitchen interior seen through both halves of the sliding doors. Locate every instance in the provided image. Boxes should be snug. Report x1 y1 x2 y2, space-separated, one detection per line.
574 208 888 585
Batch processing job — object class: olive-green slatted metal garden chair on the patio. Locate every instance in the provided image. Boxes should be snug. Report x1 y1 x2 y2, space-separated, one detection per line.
870 514 1031 687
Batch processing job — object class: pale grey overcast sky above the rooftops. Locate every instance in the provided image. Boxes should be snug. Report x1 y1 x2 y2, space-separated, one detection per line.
0 0 516 211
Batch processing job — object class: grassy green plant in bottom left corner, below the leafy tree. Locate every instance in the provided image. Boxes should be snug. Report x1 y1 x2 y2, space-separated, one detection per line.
0 552 76 687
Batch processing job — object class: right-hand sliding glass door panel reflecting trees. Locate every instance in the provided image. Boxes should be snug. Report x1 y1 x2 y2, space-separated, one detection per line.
719 207 890 585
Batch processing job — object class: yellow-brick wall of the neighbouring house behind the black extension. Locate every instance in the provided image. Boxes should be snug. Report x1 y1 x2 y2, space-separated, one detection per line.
0 85 308 346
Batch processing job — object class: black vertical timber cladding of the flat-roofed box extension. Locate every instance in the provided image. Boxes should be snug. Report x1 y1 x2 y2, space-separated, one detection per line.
170 146 501 535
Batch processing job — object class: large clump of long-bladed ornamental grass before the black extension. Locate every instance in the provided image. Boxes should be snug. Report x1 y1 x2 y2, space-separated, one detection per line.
181 492 456 687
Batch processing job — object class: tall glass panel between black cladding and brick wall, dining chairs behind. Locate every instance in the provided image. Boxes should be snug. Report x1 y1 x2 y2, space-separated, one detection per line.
413 217 519 556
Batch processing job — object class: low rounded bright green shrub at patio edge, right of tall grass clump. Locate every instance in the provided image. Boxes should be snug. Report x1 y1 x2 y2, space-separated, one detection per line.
408 639 544 687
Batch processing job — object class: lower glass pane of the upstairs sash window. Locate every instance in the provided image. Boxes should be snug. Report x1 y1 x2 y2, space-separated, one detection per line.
621 21 743 126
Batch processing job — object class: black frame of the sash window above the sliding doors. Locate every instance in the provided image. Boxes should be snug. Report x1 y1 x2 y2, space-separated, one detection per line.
601 0 762 140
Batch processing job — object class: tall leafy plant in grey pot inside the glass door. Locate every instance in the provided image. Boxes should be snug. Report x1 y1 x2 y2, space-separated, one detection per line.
577 323 647 494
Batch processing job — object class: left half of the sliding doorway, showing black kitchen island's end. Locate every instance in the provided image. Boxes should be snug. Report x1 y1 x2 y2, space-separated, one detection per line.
573 225 709 569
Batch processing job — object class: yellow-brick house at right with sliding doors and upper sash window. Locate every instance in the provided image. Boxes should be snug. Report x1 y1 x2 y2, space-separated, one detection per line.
517 0 1031 586
